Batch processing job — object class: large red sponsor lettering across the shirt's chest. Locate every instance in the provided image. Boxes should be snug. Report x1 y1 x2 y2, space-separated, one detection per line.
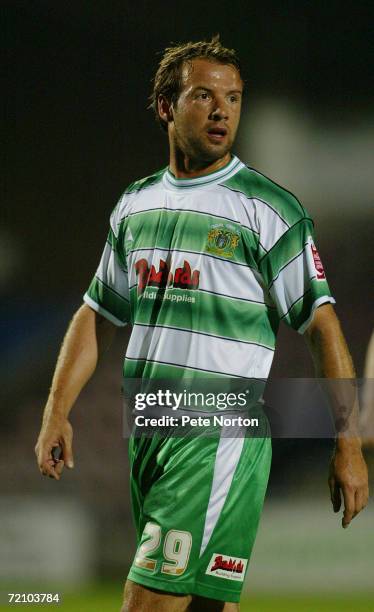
135 259 200 294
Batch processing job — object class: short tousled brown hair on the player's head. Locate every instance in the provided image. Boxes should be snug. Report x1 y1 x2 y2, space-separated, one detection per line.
149 34 241 130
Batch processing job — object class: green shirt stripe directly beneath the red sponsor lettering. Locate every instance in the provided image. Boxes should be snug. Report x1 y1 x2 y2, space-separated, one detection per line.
130 287 279 349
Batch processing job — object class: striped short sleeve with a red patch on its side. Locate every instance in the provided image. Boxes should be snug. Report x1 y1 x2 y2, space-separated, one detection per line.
259 217 335 334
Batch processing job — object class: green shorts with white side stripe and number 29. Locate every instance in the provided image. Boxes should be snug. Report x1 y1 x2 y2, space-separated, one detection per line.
128 426 271 602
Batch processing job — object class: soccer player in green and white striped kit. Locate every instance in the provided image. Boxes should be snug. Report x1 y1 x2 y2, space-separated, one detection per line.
36 37 368 612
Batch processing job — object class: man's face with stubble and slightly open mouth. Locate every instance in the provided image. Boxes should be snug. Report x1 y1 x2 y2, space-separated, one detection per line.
169 58 243 163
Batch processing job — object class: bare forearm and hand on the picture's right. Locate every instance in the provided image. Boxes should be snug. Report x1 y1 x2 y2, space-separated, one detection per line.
305 304 369 528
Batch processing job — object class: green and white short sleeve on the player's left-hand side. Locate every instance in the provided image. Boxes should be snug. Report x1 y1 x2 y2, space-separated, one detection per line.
83 206 131 326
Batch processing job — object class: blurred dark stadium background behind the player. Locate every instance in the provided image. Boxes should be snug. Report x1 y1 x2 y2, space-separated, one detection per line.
0 0 374 612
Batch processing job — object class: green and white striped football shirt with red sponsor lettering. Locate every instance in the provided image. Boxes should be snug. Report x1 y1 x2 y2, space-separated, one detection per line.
84 156 334 379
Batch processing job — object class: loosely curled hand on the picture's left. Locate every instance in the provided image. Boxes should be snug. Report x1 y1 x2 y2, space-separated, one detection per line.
35 416 74 480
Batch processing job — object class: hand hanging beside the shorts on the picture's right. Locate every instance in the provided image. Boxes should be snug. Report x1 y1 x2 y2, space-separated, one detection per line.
329 441 369 529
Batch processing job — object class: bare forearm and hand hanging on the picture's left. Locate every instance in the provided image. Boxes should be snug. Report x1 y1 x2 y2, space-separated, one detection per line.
35 304 116 480
